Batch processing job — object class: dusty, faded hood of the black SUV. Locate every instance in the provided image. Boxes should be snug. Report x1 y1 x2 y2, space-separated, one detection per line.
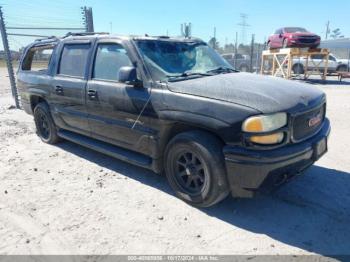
168 73 324 113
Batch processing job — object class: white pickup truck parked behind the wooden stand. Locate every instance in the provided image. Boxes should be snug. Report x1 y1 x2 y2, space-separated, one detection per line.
292 54 349 74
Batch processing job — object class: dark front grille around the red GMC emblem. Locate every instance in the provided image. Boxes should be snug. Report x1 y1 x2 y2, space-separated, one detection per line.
292 104 326 141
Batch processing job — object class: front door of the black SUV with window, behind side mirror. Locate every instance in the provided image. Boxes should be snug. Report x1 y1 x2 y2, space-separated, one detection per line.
86 42 150 149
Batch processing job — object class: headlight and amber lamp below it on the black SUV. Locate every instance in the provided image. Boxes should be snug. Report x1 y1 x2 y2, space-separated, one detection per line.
242 113 287 145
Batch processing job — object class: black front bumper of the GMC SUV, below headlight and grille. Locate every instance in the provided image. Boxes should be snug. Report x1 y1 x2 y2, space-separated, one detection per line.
223 119 331 197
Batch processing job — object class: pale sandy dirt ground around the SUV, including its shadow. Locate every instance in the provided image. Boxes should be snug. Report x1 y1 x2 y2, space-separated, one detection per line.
0 69 350 256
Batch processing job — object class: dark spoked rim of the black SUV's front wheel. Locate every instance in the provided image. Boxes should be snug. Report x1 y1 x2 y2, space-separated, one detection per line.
175 150 209 195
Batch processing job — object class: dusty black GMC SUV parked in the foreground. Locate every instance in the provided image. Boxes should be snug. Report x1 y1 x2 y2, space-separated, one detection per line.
17 34 330 207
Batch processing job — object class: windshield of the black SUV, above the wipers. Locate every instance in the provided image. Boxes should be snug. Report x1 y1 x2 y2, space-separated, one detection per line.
136 40 233 81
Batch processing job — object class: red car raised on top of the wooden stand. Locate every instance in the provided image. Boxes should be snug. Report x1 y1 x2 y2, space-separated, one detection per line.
267 27 321 49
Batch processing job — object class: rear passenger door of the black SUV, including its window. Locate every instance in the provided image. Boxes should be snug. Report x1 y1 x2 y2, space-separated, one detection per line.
51 41 92 135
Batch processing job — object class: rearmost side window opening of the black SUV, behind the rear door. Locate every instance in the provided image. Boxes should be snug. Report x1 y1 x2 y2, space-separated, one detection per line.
21 45 54 73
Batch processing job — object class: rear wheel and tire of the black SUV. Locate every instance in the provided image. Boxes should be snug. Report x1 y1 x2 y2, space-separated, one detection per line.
34 102 60 144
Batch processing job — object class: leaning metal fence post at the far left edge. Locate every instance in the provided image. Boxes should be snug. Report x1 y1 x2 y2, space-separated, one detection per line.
0 6 20 108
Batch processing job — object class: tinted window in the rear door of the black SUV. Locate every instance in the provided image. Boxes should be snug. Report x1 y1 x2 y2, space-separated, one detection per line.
58 44 90 77
